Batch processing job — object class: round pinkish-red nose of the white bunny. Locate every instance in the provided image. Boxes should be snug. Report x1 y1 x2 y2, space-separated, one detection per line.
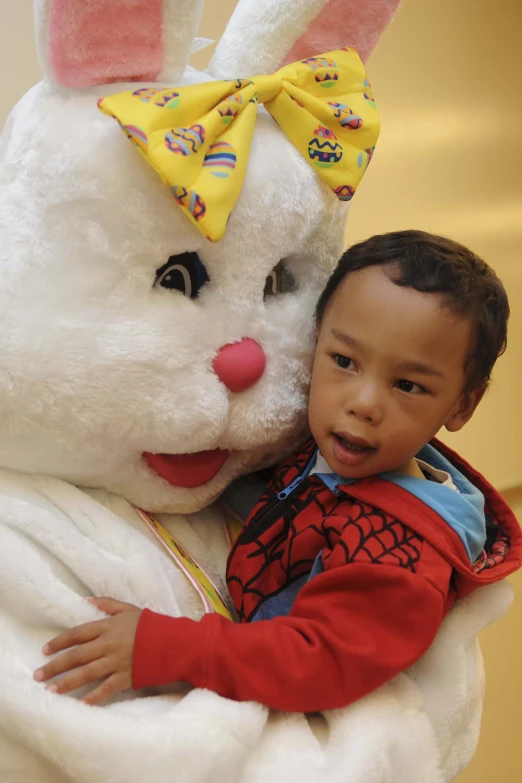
212 337 266 392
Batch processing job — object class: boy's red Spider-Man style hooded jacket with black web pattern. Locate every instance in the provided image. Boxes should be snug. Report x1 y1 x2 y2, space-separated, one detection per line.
133 441 522 712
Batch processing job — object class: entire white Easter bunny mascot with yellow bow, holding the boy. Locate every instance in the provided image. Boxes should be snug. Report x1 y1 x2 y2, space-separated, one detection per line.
0 0 509 783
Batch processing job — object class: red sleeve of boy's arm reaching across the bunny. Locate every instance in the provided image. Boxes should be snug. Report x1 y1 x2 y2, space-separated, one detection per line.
133 543 451 712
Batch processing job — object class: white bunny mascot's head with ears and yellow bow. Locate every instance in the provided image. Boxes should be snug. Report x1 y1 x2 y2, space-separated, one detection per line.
0 0 388 512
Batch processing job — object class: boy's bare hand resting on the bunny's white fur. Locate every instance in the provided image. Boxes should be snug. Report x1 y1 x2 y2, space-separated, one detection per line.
34 598 141 704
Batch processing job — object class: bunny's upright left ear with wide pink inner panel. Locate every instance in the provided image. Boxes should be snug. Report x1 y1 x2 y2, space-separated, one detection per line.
34 0 203 89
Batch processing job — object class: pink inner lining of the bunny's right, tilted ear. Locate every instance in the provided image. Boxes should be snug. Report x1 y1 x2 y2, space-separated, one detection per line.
284 0 401 64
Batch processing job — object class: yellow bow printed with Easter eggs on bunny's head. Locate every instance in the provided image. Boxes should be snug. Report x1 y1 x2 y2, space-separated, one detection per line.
98 49 379 242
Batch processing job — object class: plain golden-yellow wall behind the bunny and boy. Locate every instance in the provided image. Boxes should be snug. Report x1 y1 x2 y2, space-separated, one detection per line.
0 0 522 783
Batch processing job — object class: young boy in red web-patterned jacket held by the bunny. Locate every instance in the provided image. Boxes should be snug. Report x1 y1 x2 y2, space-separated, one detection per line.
35 231 522 712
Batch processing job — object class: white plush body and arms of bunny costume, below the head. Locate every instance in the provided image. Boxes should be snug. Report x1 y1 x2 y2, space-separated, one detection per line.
0 471 511 783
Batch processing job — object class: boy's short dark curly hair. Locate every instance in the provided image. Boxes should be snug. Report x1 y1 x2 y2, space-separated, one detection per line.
316 231 509 391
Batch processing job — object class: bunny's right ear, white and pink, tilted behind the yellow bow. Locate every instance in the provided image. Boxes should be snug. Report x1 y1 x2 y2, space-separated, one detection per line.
210 0 401 78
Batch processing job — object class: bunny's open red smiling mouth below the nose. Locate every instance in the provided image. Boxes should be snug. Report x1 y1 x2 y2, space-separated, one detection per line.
143 449 230 489
